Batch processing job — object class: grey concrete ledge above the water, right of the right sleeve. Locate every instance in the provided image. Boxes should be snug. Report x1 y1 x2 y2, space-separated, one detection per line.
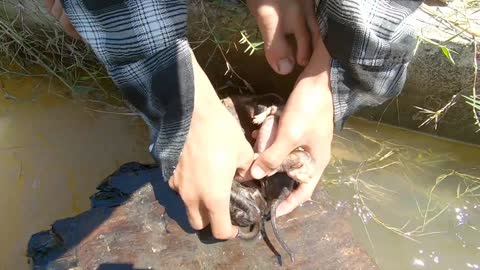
357 0 480 144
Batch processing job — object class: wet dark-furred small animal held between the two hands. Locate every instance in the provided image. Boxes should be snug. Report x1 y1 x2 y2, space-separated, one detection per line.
223 94 295 262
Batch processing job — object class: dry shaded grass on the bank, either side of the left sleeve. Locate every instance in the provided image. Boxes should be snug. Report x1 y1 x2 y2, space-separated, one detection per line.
0 0 259 107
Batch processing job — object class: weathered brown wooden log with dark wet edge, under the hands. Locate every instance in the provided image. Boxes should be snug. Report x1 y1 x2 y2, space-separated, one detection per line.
28 163 377 270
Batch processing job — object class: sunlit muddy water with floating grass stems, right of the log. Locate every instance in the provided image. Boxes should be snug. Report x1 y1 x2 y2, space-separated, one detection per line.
324 120 480 270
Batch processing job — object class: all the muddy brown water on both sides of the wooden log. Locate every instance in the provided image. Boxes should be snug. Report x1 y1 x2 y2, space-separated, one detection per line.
0 74 480 270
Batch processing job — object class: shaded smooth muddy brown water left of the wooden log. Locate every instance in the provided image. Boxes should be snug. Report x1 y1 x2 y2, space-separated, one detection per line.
0 77 150 270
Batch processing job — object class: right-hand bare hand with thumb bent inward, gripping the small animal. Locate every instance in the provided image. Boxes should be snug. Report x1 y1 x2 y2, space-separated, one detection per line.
250 38 333 216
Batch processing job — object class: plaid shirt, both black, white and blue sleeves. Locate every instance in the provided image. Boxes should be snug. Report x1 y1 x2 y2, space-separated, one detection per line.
63 0 423 180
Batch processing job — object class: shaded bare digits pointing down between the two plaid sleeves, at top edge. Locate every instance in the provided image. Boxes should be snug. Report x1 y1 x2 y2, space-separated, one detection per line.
247 0 320 75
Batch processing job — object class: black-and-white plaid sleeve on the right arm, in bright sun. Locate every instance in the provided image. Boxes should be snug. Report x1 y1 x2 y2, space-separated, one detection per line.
317 0 423 129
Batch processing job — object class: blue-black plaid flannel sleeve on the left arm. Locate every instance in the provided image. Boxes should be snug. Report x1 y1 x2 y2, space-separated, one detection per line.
63 0 194 180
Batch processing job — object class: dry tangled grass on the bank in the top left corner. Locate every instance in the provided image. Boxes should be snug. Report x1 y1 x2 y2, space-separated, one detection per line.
0 1 119 101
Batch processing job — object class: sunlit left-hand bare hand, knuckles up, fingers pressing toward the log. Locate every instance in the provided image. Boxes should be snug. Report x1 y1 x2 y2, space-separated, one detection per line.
169 53 253 240
